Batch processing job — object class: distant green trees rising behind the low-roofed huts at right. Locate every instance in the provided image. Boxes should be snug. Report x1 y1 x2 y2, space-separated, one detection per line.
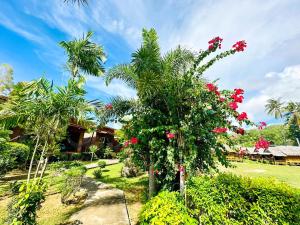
236 125 292 147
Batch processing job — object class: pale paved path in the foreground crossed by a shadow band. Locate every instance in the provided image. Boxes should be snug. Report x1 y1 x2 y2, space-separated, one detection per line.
70 178 130 225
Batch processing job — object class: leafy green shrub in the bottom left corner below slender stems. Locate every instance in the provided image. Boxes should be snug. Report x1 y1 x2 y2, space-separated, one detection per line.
8 181 46 225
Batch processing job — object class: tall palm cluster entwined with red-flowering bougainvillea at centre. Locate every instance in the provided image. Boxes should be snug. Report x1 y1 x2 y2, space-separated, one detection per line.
106 29 250 196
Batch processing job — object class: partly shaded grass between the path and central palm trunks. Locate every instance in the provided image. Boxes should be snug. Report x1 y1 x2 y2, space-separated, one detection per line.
87 163 148 224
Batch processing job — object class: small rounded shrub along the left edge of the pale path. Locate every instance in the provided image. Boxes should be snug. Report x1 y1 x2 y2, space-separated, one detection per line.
59 166 87 203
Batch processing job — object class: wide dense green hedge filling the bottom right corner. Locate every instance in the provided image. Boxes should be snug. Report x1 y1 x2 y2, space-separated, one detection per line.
187 174 300 225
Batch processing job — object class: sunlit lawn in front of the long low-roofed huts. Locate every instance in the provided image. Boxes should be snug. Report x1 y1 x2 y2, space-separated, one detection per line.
220 160 300 188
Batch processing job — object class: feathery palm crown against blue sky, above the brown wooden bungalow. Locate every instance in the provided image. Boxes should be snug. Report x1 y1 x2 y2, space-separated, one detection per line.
59 31 106 78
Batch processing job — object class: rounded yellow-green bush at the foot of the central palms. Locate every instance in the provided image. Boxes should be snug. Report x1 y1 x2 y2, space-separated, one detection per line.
140 191 198 225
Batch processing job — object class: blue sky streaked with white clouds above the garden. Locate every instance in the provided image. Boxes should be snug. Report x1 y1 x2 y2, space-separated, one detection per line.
0 0 300 128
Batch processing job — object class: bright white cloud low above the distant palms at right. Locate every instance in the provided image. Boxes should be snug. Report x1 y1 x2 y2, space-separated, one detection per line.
240 65 300 121
